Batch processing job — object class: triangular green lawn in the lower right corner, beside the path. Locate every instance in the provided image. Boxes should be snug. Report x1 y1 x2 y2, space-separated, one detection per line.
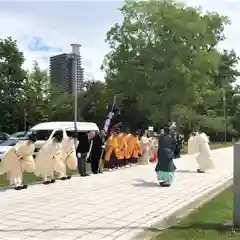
153 187 240 240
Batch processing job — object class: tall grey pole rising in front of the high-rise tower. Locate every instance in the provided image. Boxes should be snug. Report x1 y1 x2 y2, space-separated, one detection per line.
71 43 81 148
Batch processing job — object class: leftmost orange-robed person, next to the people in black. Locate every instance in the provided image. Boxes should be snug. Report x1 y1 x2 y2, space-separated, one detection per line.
104 132 118 170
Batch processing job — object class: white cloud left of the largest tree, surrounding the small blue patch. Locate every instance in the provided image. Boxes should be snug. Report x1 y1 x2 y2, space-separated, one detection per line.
0 2 123 80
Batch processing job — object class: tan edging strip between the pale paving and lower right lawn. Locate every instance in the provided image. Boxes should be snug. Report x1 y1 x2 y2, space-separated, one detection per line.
132 179 233 240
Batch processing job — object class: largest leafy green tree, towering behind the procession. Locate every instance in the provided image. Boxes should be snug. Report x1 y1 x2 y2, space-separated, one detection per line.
103 0 231 124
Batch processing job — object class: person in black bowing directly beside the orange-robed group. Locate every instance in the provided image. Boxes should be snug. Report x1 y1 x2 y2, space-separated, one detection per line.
91 132 102 174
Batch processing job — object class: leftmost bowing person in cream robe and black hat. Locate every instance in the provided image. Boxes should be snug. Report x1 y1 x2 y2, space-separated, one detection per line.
2 134 36 190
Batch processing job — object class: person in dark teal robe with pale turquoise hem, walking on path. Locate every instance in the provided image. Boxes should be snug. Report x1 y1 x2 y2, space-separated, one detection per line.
155 126 177 187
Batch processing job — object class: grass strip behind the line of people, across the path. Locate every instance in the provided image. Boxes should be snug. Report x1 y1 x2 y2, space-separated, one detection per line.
0 143 232 187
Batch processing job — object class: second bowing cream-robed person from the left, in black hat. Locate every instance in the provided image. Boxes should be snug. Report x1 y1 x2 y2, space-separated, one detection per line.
35 132 64 185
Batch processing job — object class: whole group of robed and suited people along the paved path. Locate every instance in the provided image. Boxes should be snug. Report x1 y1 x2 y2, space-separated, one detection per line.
0 122 214 190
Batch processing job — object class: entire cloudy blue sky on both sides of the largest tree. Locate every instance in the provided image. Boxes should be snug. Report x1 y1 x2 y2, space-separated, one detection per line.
0 0 240 79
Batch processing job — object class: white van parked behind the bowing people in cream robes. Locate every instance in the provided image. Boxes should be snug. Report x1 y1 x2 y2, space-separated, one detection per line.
28 122 99 152
